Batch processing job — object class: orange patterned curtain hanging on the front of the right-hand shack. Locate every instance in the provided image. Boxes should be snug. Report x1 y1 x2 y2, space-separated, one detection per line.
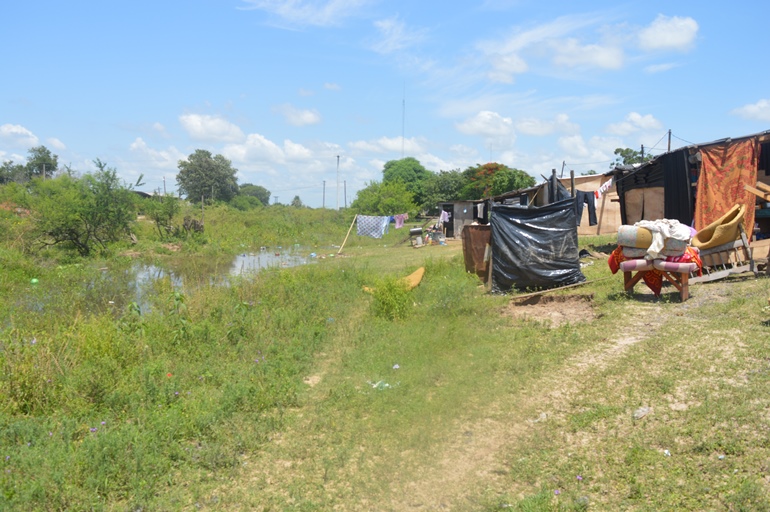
695 139 758 233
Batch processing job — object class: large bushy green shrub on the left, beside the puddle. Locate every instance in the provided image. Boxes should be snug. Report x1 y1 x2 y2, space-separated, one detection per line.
29 160 136 256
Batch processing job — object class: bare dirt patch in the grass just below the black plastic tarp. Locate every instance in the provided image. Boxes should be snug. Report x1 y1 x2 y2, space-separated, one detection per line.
503 294 596 327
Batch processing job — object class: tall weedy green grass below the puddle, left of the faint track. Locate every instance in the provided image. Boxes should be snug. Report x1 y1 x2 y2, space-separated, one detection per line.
0 247 368 510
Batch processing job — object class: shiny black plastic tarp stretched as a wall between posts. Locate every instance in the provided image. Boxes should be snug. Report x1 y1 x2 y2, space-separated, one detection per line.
490 198 586 292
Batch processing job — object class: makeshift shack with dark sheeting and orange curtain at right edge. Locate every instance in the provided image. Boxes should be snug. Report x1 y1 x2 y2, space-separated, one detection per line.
612 131 770 252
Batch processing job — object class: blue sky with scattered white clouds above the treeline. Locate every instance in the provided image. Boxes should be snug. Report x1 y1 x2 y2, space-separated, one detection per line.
0 0 770 208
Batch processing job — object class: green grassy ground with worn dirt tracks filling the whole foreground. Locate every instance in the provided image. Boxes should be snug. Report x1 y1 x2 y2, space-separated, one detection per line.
0 202 770 510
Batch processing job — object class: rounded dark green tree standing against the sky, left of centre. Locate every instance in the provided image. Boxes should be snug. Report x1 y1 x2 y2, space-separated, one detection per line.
176 149 238 202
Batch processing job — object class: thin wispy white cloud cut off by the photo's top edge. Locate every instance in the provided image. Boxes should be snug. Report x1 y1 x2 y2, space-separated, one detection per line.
244 0 369 27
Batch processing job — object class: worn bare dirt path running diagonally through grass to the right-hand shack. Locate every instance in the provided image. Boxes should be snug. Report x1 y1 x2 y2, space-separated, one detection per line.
389 283 736 511
